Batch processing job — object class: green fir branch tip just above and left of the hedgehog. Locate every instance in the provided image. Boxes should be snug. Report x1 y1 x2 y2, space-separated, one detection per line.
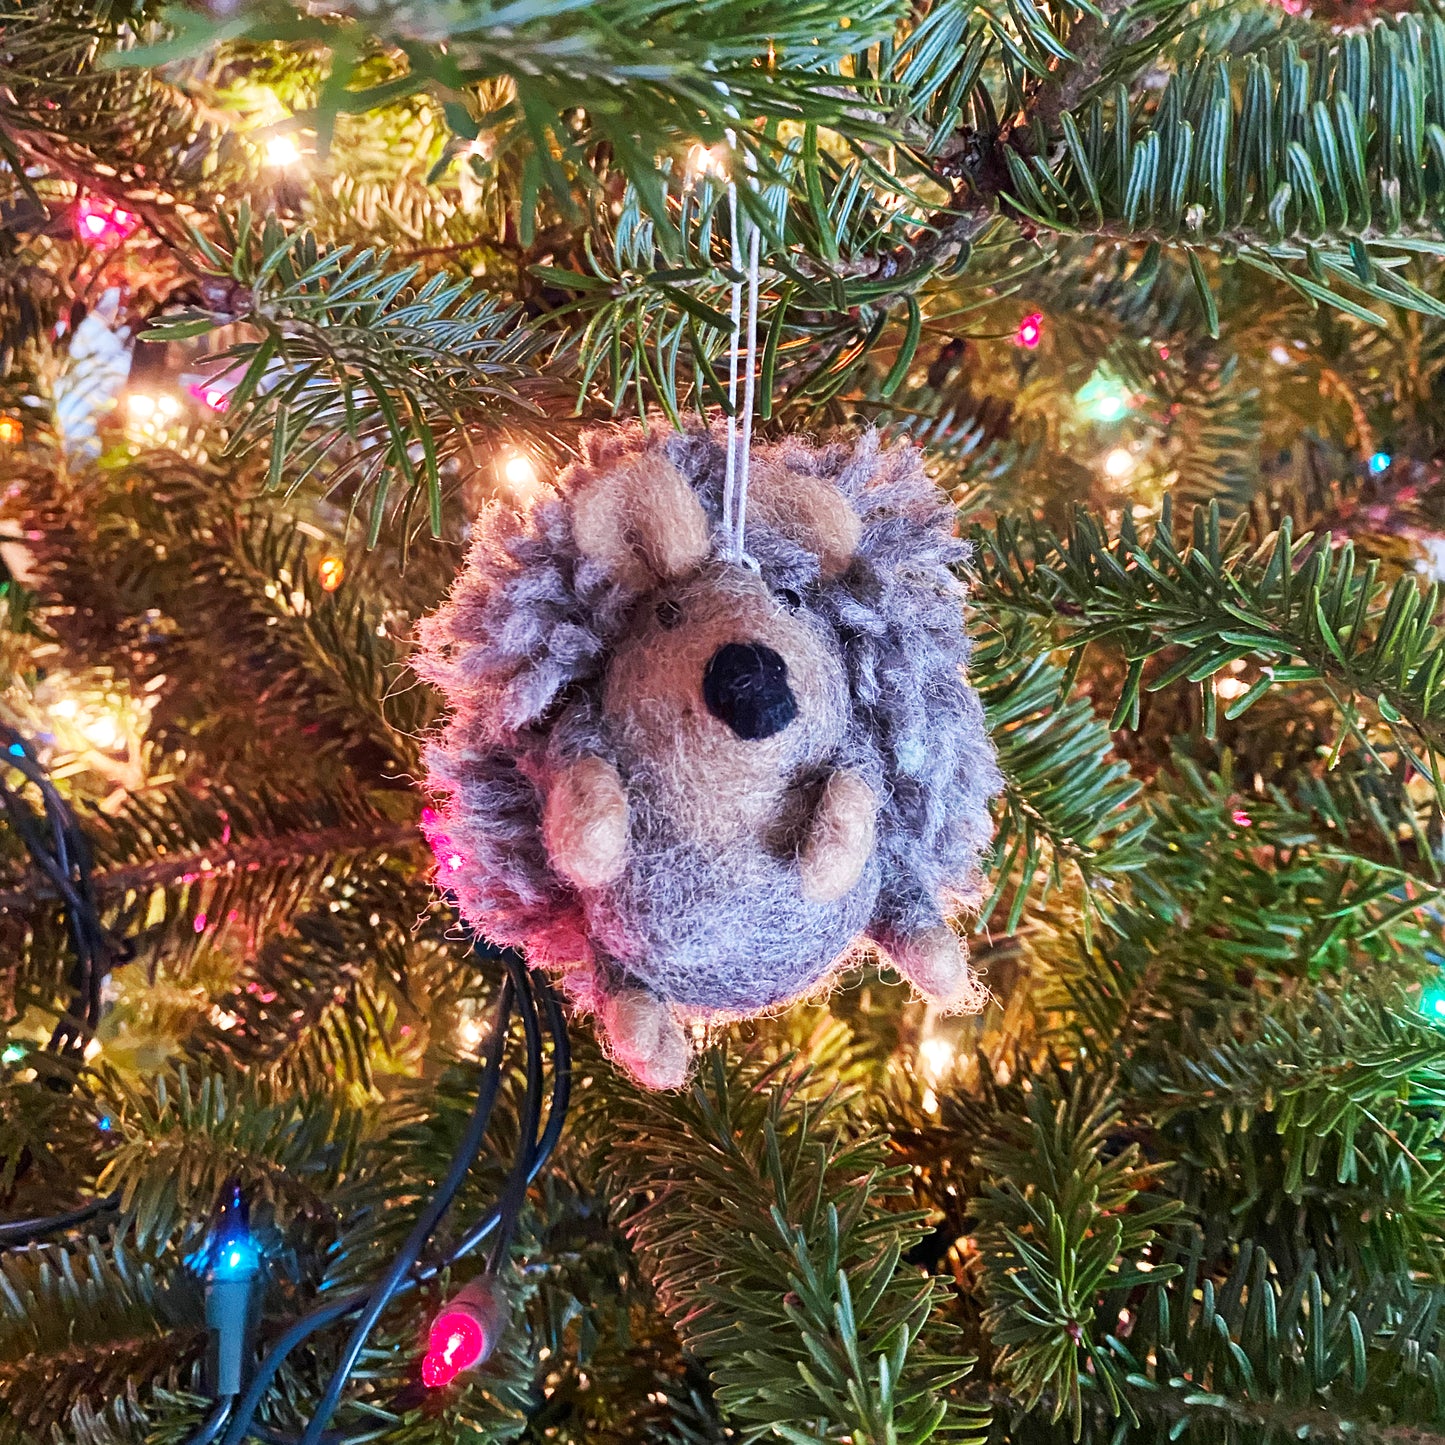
150 211 552 543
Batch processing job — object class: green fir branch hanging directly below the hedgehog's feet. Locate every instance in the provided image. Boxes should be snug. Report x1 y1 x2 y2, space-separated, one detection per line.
603 1052 980 1445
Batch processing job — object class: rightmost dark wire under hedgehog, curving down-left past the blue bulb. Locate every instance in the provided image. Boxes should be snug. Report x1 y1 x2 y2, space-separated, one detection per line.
216 972 572 1445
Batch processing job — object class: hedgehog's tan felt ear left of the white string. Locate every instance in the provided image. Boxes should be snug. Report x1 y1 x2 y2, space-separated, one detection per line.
572 449 711 592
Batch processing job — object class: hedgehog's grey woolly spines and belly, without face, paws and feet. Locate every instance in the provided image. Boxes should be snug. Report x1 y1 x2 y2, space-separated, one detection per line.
416 428 1000 1017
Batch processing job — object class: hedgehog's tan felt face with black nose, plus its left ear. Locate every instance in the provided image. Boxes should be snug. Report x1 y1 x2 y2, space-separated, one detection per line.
574 454 850 840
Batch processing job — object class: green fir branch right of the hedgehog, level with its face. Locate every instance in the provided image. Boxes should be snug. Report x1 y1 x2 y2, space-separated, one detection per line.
978 503 1445 796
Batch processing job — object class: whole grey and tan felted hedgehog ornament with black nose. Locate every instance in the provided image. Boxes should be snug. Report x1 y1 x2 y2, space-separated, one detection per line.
418 429 998 1088
